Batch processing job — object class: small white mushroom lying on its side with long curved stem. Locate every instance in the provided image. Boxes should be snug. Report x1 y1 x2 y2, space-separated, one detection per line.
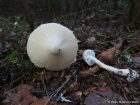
83 50 139 82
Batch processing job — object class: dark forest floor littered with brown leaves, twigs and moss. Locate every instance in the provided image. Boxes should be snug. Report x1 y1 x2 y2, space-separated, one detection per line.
0 15 140 105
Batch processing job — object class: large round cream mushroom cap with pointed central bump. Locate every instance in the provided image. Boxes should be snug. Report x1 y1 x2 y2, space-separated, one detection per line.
27 23 78 70
